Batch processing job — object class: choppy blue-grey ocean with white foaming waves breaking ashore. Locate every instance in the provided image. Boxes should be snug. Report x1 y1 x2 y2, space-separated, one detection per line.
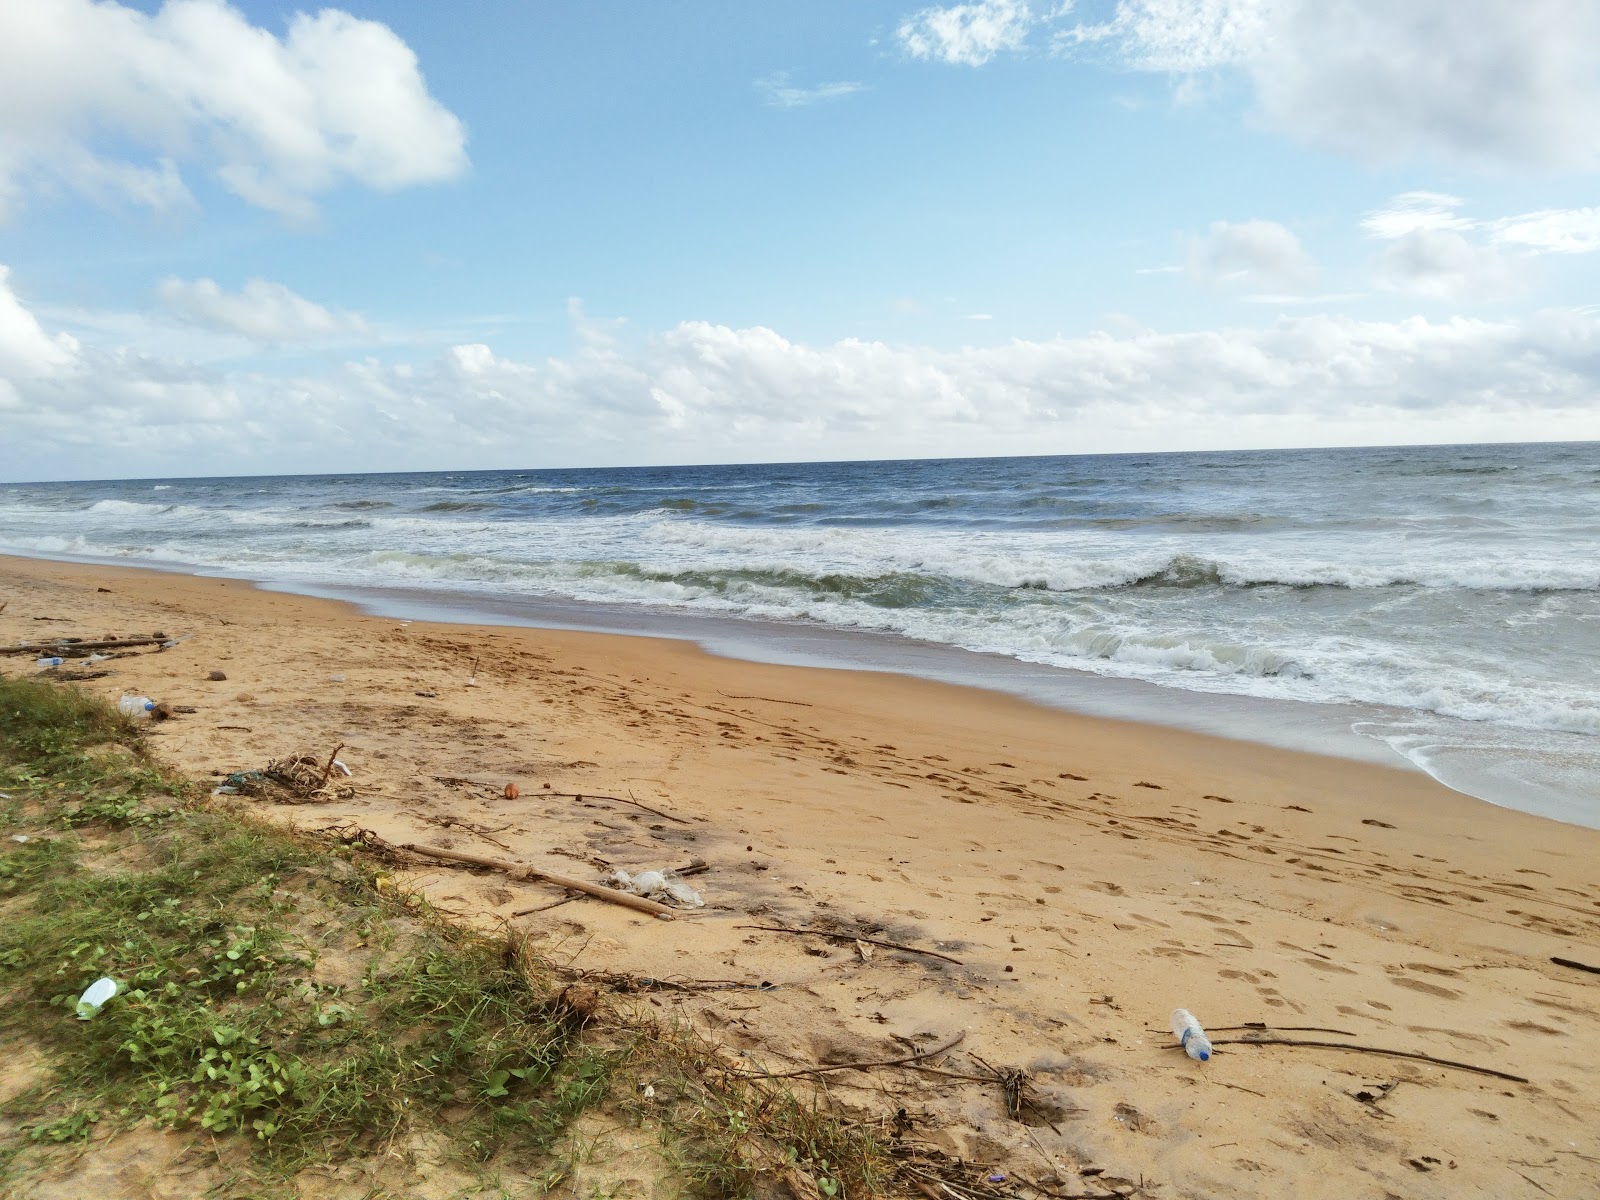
0 443 1600 826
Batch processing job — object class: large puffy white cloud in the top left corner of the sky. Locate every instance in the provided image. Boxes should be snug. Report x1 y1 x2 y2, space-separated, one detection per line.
0 0 467 219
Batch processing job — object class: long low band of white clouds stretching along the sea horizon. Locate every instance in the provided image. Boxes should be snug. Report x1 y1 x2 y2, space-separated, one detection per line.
0 267 1600 478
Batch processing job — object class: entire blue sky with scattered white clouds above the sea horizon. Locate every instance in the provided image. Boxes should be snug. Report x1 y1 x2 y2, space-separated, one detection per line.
0 0 1600 480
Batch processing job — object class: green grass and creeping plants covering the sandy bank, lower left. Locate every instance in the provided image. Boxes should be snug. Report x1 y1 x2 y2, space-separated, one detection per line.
0 678 893 1197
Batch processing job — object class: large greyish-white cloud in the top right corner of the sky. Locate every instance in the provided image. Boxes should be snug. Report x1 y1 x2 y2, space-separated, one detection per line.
1056 0 1600 170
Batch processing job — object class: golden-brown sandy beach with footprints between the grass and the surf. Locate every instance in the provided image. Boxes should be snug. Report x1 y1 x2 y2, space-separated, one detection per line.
0 558 1600 1198
